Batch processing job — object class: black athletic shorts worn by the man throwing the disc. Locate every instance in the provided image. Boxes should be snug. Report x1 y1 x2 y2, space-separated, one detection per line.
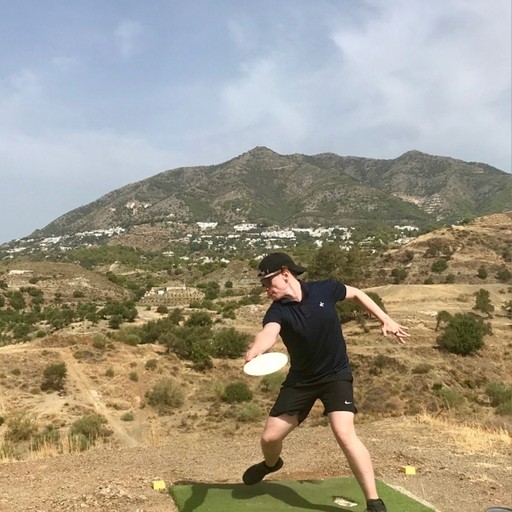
269 378 357 424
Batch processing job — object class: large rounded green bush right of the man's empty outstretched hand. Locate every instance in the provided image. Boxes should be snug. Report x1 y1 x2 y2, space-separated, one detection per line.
437 313 488 356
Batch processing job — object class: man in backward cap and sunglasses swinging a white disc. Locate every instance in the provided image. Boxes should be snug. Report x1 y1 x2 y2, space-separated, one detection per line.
242 252 409 512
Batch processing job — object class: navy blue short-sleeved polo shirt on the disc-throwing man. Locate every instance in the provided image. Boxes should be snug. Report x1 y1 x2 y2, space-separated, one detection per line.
263 279 351 386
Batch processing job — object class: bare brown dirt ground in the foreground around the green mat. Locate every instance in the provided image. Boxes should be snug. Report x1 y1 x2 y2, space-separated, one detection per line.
0 418 512 512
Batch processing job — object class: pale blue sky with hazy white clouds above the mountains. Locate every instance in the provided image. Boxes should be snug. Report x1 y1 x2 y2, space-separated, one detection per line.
0 0 512 243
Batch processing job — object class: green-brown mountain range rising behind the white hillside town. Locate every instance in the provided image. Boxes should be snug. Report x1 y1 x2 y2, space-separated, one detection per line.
17 147 512 238
